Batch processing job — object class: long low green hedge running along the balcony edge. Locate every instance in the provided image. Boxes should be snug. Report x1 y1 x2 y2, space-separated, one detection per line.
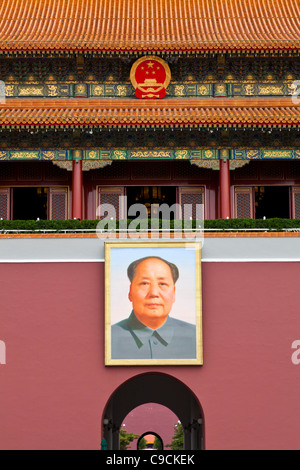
0 219 300 233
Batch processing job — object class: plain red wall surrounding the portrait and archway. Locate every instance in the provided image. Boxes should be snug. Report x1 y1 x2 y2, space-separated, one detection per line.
0 263 300 449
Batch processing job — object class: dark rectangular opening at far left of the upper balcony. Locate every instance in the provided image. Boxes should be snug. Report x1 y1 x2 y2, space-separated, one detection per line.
13 188 48 220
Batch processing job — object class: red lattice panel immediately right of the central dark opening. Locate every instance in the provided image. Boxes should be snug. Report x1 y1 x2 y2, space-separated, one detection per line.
178 186 205 220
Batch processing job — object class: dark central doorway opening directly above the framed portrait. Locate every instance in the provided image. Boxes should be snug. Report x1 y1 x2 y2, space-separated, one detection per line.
127 186 176 219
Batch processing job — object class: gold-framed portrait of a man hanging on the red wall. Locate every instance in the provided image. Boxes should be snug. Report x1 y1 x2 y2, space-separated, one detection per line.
105 242 202 365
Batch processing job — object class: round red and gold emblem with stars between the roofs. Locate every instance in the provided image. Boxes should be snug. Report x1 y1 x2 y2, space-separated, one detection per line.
130 56 171 99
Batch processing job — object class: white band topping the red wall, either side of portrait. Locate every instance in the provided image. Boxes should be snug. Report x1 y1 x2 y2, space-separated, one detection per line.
0 237 300 265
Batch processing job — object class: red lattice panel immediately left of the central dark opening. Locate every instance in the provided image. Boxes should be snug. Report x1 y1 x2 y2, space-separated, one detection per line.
96 186 126 219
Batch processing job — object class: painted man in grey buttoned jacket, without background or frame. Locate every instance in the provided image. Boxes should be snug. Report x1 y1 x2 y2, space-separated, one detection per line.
111 256 196 359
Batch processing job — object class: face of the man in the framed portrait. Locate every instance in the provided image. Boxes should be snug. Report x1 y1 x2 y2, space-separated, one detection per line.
128 258 175 329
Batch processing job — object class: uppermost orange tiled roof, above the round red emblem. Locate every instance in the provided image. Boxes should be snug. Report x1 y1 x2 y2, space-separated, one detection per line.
0 0 300 53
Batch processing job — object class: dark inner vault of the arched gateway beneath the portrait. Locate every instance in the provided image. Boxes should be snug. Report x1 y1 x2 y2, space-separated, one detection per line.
102 372 204 450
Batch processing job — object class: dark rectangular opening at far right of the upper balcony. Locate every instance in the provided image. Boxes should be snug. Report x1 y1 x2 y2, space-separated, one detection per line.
254 186 290 219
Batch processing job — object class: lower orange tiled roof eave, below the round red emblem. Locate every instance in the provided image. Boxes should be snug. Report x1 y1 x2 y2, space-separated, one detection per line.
0 97 300 128
